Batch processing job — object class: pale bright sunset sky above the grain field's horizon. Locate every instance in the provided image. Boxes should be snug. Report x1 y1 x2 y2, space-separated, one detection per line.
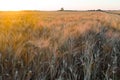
0 0 120 11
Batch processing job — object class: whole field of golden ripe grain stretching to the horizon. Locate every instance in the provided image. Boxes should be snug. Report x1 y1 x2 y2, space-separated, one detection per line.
0 11 120 80
